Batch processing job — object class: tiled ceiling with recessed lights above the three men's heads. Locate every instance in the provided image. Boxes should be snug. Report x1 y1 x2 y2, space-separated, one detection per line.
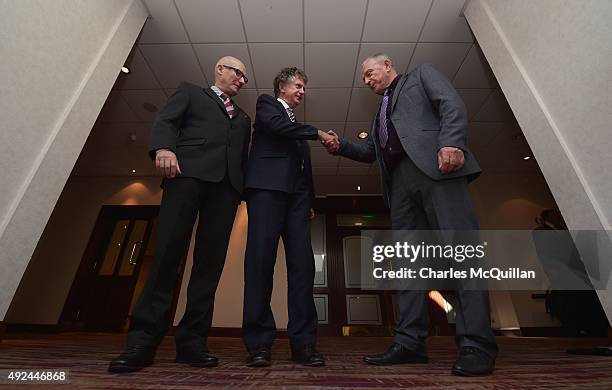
73 0 538 194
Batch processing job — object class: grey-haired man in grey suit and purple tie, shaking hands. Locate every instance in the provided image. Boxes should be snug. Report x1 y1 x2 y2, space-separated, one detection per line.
326 54 497 376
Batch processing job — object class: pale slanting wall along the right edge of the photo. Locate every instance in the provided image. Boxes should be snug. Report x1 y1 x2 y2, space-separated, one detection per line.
465 0 612 319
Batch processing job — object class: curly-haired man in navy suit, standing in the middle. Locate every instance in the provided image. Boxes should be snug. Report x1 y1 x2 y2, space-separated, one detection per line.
242 68 331 367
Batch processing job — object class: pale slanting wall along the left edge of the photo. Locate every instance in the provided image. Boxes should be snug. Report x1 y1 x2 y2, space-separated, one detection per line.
0 0 147 319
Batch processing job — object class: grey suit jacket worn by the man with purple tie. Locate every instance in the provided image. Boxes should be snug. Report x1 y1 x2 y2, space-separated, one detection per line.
338 64 481 205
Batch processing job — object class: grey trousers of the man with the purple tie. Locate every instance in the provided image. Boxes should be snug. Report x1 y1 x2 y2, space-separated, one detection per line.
391 157 497 358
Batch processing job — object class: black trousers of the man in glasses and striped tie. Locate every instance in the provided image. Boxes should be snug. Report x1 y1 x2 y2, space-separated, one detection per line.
128 176 240 348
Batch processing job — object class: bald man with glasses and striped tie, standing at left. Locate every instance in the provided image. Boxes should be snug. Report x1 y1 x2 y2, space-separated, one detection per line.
109 57 251 372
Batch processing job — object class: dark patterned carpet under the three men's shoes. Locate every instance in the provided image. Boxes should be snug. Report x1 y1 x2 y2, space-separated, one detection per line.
0 333 612 389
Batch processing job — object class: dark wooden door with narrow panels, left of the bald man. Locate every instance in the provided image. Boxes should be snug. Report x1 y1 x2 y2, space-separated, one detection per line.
60 206 189 331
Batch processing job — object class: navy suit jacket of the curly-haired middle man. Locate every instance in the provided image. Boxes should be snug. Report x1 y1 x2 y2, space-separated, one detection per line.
245 94 317 198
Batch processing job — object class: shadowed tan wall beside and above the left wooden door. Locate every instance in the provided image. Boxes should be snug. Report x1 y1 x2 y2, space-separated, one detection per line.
6 177 161 324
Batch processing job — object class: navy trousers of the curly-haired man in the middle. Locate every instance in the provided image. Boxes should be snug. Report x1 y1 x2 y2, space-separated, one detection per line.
242 175 317 350
